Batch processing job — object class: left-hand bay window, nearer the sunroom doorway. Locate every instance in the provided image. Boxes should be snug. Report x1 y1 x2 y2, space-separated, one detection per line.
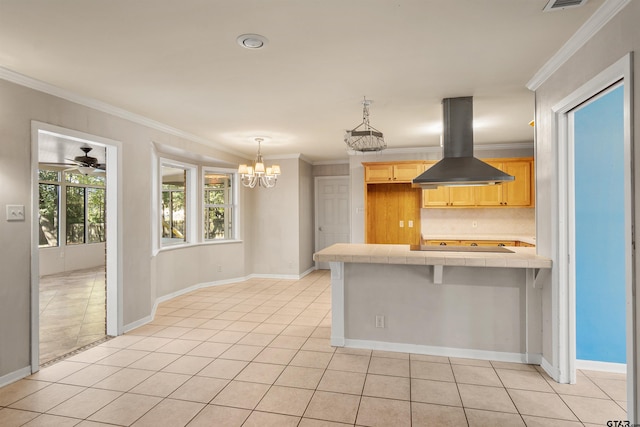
161 164 191 246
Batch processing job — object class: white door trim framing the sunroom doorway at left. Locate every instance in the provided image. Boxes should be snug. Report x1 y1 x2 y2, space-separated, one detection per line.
31 120 123 372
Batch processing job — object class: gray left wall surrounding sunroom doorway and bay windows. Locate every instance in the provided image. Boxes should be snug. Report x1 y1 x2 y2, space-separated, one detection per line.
0 80 313 382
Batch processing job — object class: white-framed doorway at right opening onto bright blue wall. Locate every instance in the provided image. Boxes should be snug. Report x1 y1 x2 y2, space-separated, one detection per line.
553 54 638 422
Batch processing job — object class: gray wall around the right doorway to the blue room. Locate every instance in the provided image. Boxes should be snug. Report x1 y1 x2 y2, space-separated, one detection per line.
536 1 640 378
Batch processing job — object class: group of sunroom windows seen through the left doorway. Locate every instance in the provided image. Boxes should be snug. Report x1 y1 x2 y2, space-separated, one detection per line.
38 170 105 247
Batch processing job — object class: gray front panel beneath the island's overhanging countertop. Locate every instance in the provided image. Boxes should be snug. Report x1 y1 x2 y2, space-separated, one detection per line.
344 263 540 354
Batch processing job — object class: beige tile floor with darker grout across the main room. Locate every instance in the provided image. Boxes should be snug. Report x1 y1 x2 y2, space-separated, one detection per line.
0 271 626 427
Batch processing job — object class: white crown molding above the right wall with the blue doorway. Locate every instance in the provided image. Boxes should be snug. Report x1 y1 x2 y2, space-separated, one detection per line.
527 0 631 91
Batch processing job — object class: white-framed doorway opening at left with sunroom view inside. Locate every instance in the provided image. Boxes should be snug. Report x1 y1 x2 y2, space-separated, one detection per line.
31 122 122 372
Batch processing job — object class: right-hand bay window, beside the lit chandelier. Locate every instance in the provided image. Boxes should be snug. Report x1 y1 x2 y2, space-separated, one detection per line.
203 171 234 241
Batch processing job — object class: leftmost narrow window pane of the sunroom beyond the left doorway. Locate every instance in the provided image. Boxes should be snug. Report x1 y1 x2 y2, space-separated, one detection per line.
38 170 60 248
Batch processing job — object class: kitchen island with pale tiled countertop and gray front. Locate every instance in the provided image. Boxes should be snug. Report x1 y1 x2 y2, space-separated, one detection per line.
314 243 551 363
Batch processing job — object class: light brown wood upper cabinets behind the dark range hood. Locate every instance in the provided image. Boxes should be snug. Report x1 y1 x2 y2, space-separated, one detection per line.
422 157 534 208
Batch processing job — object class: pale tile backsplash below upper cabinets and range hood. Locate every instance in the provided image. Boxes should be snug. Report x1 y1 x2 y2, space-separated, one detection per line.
420 208 536 236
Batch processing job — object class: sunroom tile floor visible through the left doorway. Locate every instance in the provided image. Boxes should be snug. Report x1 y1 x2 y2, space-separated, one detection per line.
40 267 106 364
